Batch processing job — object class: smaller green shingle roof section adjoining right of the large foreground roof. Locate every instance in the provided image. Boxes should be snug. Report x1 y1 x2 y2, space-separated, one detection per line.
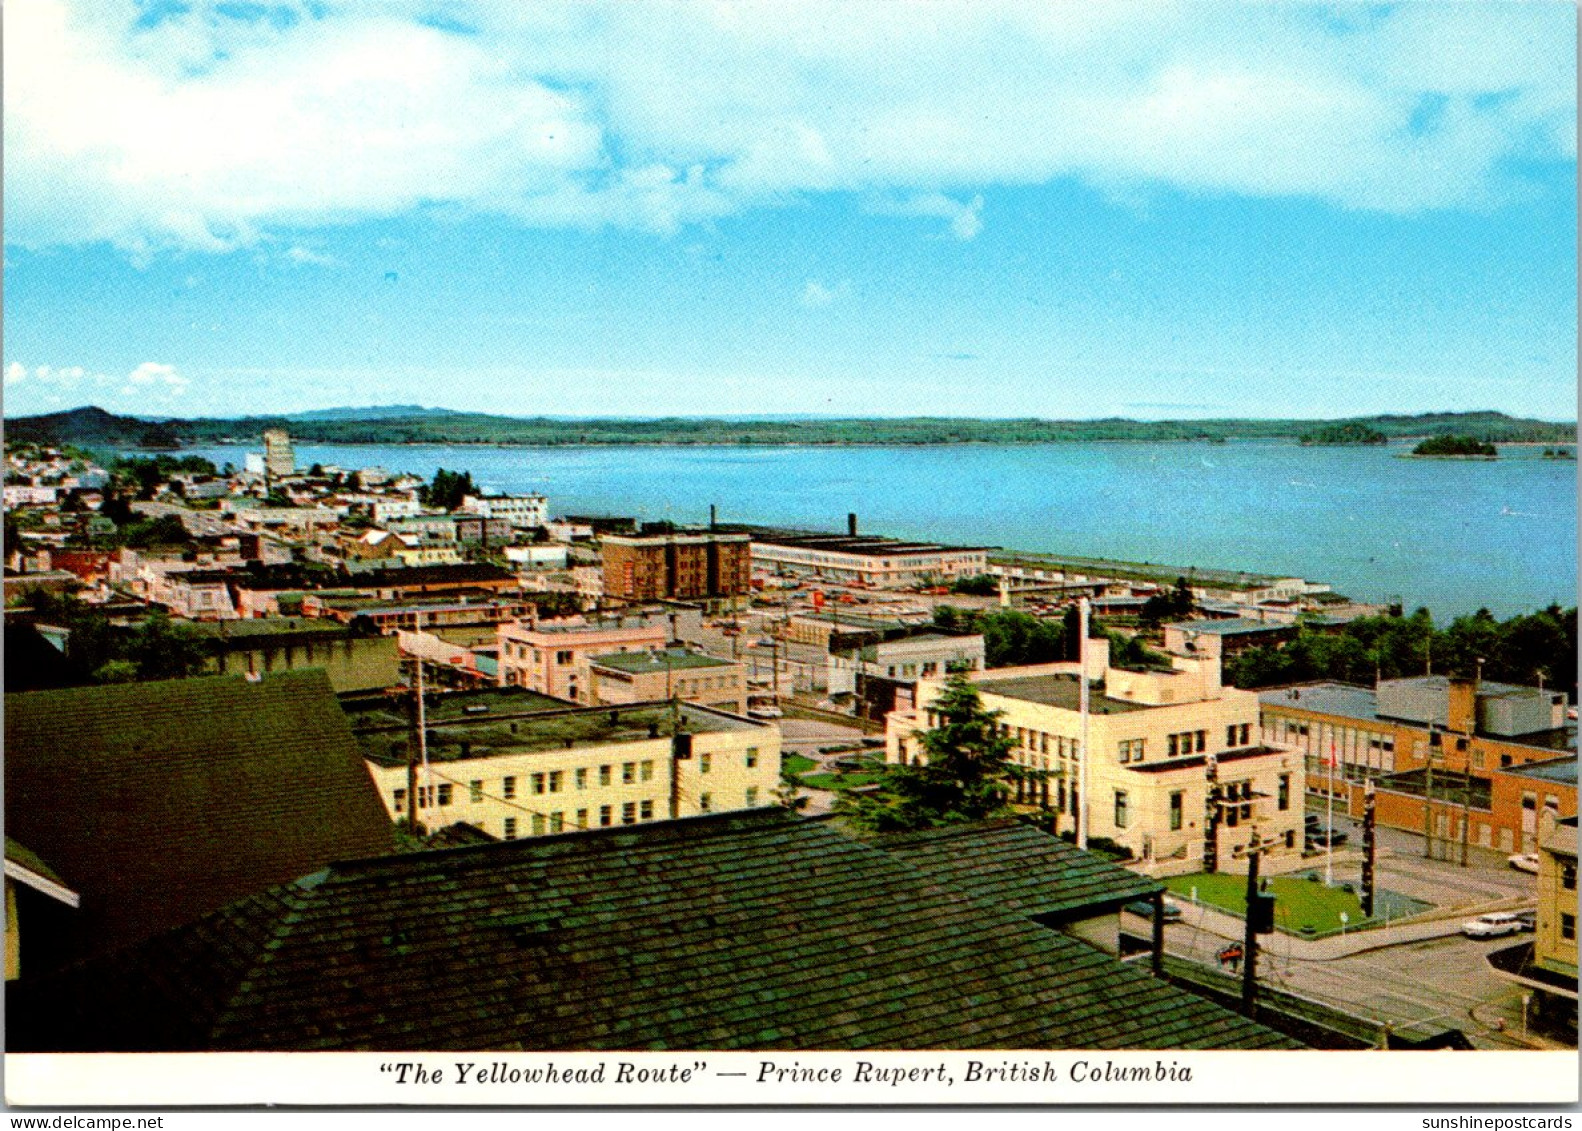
875 821 1164 919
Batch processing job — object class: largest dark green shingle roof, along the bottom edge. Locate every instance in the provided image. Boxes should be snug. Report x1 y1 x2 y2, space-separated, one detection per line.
6 810 1292 1052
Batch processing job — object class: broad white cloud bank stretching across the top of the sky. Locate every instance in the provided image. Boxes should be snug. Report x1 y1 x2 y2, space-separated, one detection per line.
5 0 1576 259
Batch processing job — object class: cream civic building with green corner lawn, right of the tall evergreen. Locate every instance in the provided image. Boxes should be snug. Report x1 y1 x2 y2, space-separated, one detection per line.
886 641 1304 875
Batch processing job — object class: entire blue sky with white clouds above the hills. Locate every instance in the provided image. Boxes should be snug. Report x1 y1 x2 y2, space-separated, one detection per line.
3 0 1577 421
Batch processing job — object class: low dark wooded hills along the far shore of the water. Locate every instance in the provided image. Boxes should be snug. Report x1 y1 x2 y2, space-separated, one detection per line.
6 405 1576 448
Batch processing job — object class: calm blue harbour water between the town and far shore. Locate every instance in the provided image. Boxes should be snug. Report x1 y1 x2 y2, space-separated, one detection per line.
181 443 1577 620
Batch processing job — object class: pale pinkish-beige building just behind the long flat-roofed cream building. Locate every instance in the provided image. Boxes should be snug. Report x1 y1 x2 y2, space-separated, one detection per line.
497 617 669 704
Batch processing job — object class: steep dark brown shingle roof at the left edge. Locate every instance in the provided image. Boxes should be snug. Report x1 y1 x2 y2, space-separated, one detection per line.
5 669 392 960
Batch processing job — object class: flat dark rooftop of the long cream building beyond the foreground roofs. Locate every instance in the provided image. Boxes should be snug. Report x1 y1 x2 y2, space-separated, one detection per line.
358 702 769 766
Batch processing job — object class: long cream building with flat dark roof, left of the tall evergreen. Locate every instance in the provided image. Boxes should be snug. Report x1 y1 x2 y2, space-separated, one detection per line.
354 691 780 840
